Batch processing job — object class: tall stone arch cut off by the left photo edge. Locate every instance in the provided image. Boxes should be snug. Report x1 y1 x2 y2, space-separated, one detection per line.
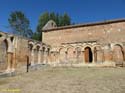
0 39 8 70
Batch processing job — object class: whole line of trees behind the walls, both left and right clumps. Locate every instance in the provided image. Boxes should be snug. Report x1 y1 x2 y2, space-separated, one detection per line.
8 11 71 41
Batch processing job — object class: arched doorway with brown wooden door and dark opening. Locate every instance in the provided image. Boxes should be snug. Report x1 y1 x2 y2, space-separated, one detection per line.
85 47 93 63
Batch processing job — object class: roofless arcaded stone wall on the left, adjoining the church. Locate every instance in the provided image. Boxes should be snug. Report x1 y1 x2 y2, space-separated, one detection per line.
0 32 49 72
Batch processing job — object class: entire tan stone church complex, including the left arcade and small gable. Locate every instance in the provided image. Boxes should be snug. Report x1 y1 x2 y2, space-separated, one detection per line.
0 19 125 72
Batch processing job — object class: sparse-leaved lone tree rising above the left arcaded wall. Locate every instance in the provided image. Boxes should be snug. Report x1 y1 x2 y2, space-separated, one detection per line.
8 11 33 38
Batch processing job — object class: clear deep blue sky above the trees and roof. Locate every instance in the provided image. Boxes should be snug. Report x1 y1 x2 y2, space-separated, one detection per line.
0 0 125 32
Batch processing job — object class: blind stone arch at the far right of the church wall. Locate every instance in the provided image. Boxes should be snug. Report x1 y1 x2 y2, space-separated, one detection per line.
113 44 125 63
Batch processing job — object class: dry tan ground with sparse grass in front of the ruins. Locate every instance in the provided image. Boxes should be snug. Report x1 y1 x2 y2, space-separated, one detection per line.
0 67 125 93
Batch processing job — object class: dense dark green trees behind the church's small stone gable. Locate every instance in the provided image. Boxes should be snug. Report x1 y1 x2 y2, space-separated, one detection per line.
33 12 71 40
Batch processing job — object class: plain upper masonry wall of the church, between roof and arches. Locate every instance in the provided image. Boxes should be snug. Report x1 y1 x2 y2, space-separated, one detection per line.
43 22 125 46
